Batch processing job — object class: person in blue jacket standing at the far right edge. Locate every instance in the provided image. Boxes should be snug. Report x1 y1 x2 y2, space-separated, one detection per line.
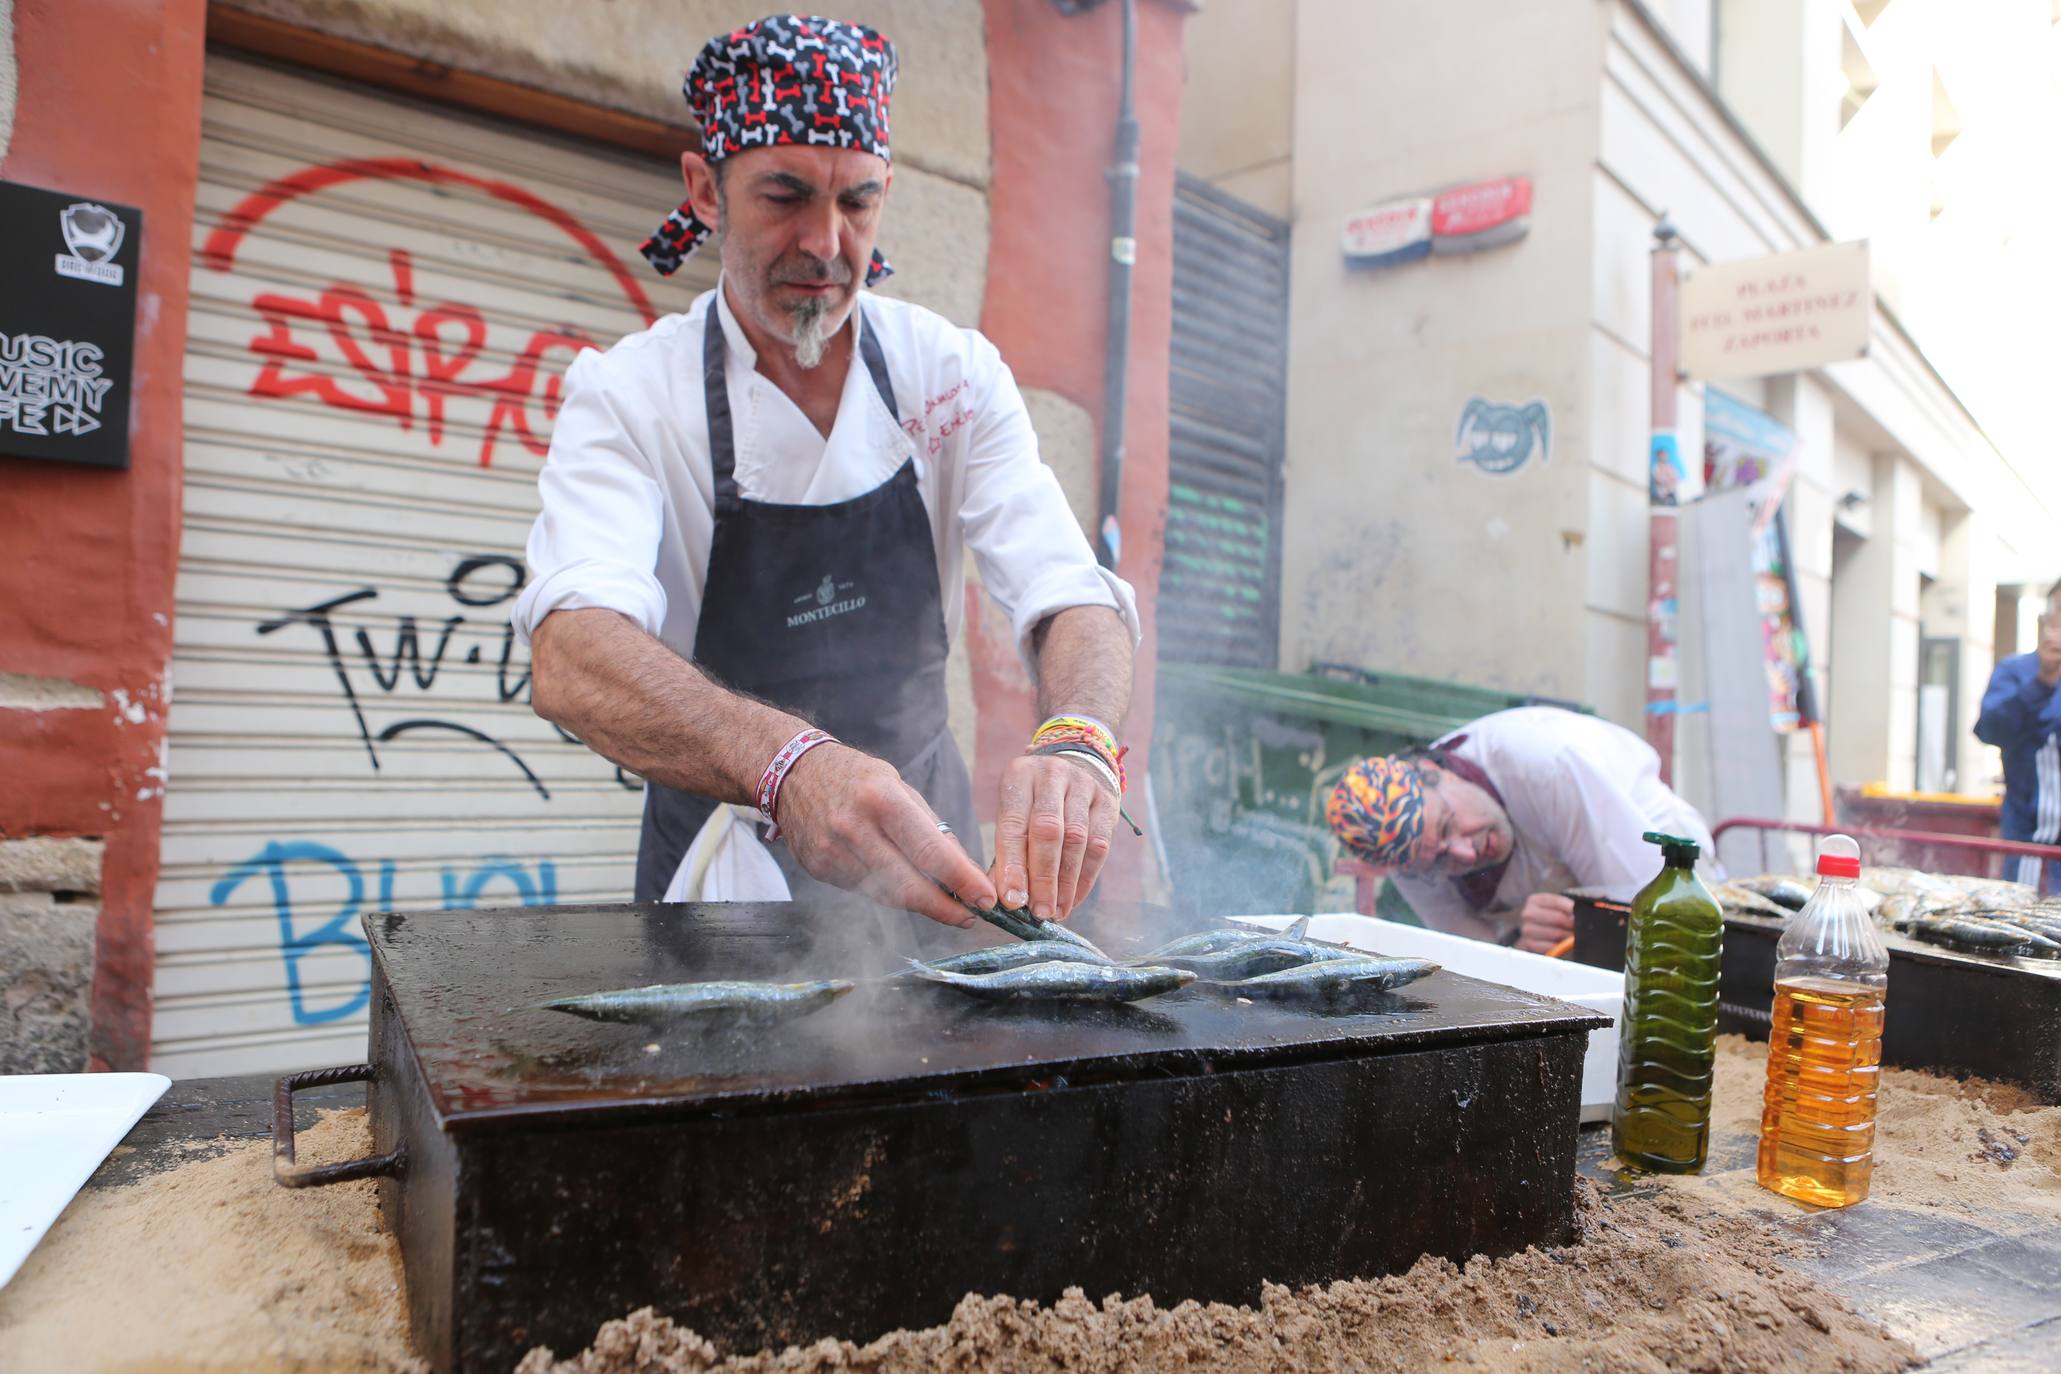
1974 583 2061 892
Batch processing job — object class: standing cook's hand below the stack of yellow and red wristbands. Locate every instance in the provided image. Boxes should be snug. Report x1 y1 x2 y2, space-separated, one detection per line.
993 754 1117 921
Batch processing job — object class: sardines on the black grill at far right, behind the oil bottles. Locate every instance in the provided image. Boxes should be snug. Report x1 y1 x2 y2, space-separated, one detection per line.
1711 867 2061 960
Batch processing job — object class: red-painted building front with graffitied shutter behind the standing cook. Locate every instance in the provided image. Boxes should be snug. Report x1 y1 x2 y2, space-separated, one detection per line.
0 0 1187 1075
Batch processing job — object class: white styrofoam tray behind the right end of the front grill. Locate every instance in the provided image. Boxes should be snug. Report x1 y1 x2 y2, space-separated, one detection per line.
1239 913 1624 1121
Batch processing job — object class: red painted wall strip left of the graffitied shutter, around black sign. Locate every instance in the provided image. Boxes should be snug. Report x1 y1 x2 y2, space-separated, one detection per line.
0 0 206 1069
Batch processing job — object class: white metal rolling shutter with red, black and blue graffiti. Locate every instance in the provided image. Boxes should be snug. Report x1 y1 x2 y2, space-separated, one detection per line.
153 54 713 1075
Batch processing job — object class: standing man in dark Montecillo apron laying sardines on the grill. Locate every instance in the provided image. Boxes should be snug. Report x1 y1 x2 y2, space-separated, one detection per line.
513 14 1138 927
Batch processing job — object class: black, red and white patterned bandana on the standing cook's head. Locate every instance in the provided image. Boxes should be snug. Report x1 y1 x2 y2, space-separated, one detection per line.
641 14 899 286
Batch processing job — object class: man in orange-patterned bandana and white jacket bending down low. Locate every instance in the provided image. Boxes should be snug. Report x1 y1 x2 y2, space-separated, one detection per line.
1325 707 1717 952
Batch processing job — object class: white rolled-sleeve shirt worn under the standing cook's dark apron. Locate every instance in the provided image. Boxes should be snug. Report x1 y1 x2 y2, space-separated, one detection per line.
511 288 1140 676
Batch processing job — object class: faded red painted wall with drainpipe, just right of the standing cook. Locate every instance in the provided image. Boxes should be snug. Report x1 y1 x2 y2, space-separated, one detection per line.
969 0 1187 896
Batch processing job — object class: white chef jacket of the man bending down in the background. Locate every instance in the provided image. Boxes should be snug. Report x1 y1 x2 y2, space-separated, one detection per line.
1391 707 1721 939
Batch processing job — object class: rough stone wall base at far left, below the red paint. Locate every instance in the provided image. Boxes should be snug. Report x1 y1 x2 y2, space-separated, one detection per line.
0 836 105 1073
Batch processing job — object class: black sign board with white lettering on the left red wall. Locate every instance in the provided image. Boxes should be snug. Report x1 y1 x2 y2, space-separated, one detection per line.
0 181 142 468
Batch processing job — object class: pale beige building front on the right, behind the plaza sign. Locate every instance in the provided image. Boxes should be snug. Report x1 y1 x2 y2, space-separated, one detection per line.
1181 0 2061 861
